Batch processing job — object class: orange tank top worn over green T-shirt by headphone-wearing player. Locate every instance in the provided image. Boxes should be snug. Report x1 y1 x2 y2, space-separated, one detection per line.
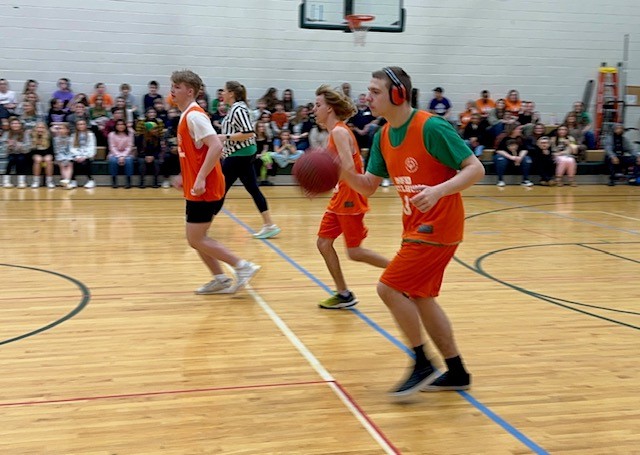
380 111 464 245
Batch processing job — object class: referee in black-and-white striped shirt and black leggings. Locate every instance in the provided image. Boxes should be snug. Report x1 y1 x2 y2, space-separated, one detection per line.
218 81 280 239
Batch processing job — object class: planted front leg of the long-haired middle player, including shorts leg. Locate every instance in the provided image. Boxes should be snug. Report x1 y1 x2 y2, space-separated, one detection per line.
316 212 358 310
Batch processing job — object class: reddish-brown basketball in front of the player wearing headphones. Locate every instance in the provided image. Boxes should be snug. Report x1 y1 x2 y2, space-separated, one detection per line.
292 149 340 194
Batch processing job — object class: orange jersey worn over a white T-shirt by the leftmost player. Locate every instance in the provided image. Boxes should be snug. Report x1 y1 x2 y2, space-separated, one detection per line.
178 104 225 201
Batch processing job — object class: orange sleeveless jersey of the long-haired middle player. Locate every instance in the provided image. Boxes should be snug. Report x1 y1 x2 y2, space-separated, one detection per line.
327 122 369 215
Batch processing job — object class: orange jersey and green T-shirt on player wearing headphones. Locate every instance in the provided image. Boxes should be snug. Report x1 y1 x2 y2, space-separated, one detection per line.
367 110 472 245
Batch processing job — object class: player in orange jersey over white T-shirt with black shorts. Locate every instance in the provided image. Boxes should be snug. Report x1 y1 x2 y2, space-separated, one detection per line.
171 70 260 294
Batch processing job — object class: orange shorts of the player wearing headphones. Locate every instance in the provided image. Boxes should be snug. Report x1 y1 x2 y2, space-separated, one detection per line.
380 243 458 298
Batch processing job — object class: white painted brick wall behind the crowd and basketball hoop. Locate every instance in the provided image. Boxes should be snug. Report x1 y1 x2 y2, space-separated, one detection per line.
0 0 640 124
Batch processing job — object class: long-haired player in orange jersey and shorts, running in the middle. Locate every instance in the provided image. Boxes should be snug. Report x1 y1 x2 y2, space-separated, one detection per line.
313 85 389 310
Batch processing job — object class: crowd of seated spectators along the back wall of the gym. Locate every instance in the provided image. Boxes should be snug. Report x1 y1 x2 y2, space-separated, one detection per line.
0 78 640 188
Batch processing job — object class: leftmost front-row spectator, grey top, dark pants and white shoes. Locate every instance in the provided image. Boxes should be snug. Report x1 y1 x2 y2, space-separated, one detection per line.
0 117 30 188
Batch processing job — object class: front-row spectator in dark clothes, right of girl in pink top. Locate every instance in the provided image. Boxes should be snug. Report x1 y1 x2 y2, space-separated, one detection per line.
136 108 164 188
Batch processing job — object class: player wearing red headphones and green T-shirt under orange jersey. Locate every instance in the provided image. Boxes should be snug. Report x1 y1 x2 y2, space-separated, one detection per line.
341 67 484 397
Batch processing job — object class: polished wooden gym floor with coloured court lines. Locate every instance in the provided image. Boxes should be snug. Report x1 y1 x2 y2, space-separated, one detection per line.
0 186 640 455
